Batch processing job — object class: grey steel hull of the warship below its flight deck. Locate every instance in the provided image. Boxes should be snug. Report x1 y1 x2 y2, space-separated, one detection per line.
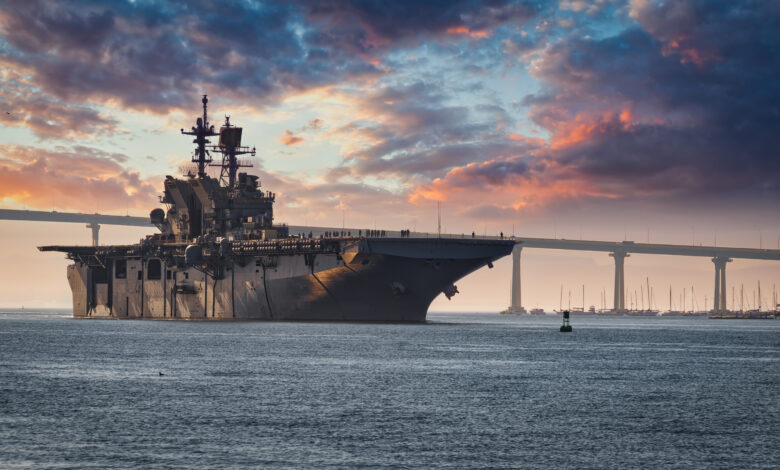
62 239 513 322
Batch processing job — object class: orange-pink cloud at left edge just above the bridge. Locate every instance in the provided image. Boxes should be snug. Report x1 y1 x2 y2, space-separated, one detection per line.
0 145 158 212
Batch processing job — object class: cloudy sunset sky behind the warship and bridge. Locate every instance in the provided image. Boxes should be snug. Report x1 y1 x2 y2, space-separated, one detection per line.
0 0 780 311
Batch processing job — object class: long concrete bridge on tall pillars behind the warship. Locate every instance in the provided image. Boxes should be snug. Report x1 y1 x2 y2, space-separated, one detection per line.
0 209 780 313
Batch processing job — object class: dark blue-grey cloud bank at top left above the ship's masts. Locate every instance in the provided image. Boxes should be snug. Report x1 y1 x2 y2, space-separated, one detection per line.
0 0 535 111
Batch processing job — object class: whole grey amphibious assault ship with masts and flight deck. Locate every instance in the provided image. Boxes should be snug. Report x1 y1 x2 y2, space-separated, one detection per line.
39 95 514 322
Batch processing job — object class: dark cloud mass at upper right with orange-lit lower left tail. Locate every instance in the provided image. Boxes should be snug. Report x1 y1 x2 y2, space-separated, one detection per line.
411 0 780 212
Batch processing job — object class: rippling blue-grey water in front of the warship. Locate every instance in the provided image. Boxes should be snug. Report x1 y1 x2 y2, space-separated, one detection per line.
0 312 780 469
